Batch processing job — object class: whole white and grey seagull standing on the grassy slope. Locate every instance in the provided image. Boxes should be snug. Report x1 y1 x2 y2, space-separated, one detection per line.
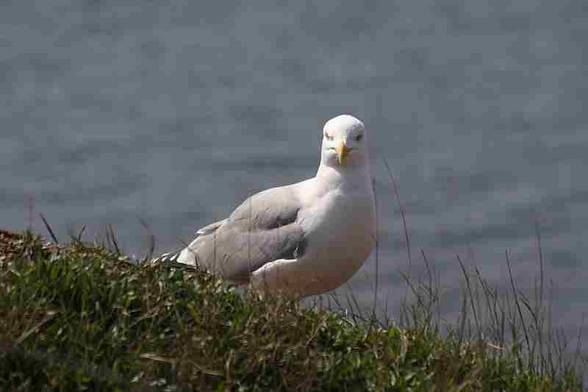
154 114 376 298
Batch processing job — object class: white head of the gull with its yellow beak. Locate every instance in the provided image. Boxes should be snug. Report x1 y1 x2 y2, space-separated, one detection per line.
321 114 368 170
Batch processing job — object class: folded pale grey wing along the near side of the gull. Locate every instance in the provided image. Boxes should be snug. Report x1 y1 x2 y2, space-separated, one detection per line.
184 186 304 283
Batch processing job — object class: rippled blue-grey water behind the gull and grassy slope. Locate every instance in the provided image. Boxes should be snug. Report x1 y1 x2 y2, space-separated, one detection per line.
0 0 588 350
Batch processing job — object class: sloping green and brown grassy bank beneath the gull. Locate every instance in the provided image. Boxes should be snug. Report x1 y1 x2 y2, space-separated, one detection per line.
0 231 582 391
